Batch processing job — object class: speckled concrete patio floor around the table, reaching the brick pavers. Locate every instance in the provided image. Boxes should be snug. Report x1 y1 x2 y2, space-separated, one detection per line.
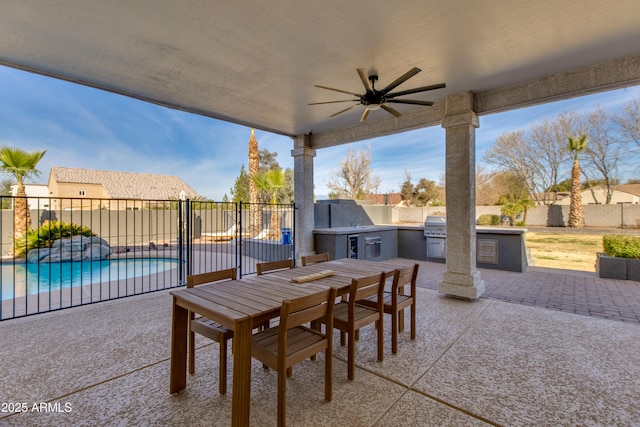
0 260 640 426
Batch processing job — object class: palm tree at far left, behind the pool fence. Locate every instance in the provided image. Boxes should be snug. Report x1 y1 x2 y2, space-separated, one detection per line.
0 146 47 237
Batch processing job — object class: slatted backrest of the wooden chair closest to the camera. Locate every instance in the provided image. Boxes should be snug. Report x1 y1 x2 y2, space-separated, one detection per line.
279 288 337 335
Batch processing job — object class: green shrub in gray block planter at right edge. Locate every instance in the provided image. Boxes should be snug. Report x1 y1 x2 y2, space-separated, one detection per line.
596 235 640 281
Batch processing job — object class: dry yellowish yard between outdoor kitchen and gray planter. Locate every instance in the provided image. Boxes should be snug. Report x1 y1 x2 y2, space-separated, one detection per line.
525 231 603 272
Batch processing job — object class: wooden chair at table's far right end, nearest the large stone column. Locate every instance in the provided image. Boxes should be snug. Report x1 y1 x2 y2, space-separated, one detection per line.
360 264 419 354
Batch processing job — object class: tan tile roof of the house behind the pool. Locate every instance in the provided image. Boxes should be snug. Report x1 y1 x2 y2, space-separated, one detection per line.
51 167 202 200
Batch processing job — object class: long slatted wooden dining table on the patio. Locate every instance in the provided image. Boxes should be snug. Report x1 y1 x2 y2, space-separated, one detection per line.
169 258 405 426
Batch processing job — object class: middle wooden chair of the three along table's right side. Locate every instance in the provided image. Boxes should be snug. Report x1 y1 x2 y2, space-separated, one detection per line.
321 273 386 380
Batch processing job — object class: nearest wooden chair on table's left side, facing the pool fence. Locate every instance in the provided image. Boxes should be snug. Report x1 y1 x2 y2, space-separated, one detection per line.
187 268 236 394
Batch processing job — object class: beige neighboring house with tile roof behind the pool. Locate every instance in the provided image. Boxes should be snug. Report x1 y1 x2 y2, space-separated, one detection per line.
48 167 202 210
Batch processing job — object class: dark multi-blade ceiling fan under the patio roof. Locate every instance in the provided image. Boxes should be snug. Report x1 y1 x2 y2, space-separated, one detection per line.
309 67 446 122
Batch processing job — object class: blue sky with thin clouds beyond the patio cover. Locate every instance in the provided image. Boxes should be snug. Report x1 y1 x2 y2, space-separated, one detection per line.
0 66 640 200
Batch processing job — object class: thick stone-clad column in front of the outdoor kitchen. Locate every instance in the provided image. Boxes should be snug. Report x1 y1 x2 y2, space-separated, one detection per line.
438 92 484 299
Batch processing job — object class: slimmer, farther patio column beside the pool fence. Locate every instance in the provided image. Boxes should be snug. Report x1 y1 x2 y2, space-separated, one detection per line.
291 135 316 264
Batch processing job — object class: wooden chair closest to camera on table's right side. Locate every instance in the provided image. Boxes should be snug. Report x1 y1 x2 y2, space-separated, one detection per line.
251 288 336 426
